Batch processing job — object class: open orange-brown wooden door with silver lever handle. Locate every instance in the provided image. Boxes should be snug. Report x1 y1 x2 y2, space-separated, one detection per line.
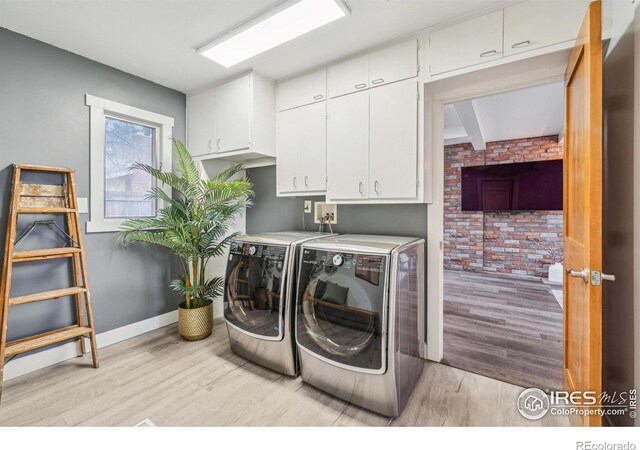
564 1 602 426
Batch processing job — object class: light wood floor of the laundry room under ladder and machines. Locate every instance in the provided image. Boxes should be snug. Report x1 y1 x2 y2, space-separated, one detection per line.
0 321 568 426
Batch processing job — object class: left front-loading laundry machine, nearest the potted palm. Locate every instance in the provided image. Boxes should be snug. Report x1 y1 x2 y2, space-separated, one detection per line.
224 232 331 375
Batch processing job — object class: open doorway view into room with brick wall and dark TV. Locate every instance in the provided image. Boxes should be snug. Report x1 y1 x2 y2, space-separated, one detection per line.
442 81 564 390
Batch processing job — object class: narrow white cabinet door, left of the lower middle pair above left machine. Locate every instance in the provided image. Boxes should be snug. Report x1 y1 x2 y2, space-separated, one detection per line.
276 108 304 193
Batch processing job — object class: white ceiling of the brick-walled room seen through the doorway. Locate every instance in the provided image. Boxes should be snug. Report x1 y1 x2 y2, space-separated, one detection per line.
445 81 564 145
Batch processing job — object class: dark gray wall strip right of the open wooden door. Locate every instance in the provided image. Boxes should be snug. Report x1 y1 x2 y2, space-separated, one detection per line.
602 5 638 425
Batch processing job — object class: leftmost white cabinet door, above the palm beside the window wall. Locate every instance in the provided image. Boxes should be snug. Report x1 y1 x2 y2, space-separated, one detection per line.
187 89 215 156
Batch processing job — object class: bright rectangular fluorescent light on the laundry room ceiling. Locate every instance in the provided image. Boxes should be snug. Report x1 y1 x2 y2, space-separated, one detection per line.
198 0 349 67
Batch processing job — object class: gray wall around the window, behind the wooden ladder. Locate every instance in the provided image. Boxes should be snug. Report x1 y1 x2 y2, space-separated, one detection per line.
0 28 186 339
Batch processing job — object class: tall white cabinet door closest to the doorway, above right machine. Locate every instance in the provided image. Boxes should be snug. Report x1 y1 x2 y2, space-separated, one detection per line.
369 80 418 199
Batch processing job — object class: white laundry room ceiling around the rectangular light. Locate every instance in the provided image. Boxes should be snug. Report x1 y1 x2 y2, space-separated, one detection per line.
0 0 506 93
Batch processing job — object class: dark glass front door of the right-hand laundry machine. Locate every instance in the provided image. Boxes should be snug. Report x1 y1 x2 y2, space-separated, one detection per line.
296 249 388 373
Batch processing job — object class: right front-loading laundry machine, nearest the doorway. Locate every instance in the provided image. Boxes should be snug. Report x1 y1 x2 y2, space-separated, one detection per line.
296 235 425 417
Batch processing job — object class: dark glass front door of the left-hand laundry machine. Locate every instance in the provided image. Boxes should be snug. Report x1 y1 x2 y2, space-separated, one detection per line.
224 241 287 340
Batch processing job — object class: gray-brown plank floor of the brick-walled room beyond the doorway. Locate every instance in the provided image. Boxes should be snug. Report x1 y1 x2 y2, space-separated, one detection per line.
443 270 563 390
